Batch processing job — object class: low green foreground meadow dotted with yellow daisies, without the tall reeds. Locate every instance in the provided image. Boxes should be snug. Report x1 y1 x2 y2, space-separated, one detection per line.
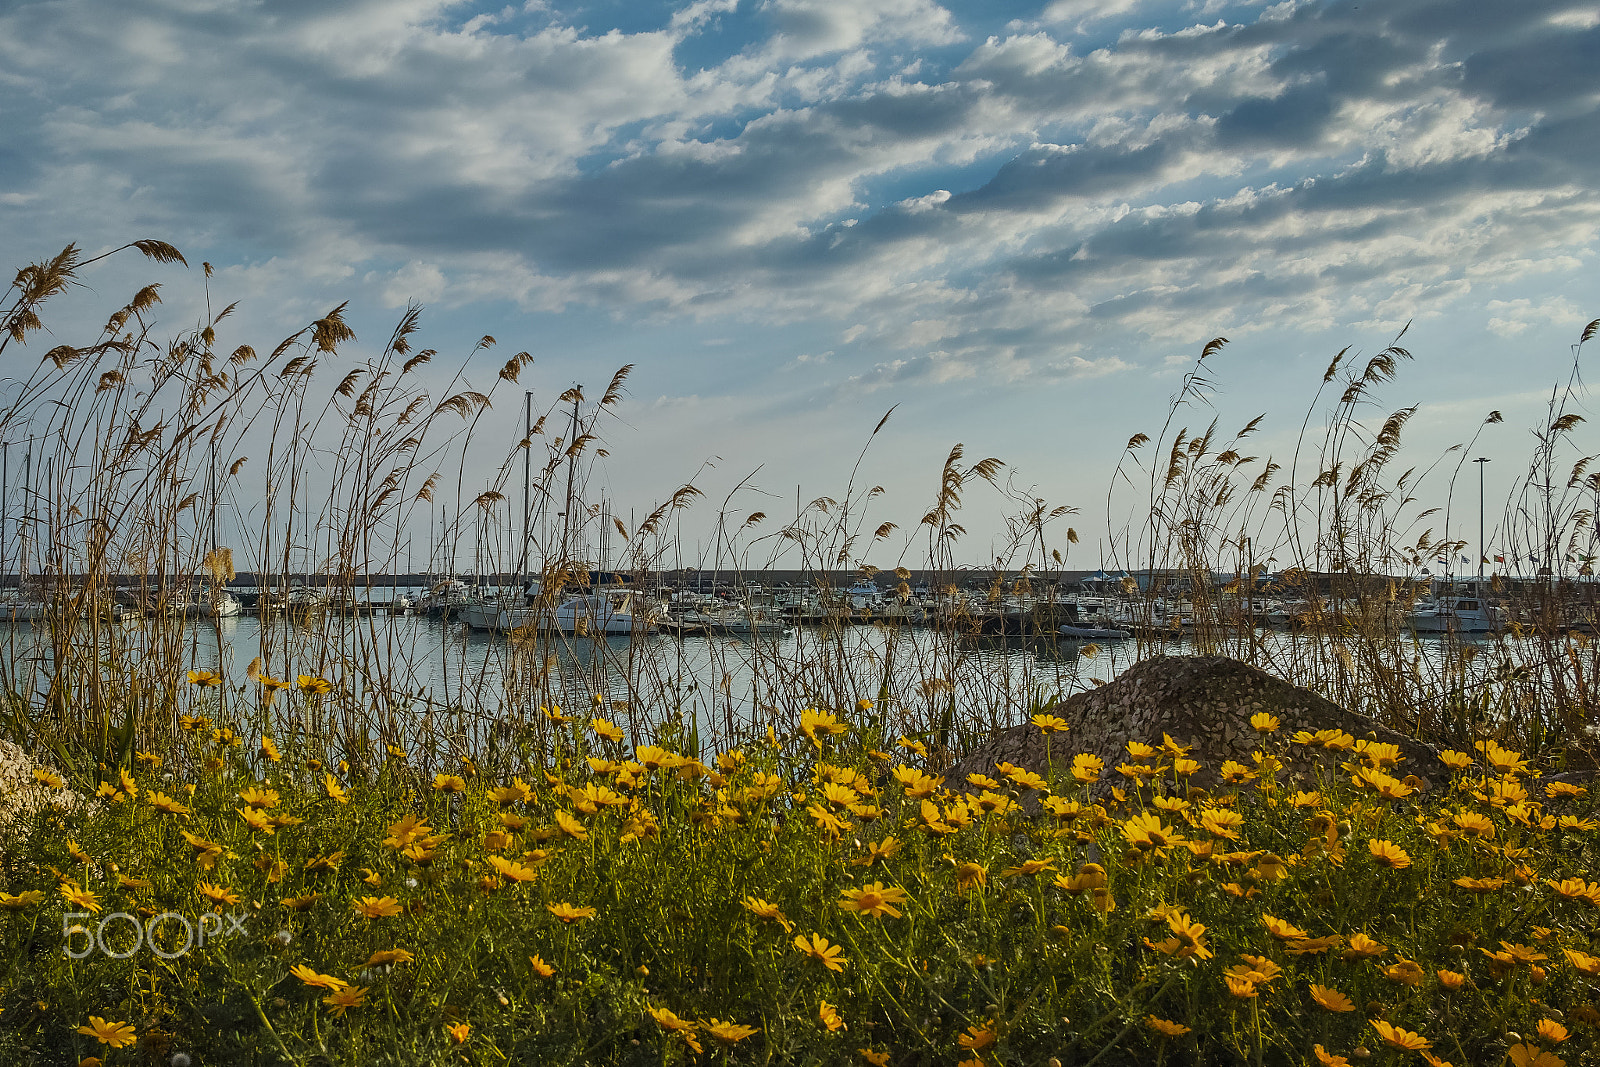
0 697 1600 1065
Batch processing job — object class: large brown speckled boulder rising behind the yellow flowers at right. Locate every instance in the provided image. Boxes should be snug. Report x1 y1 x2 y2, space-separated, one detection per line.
946 656 1448 789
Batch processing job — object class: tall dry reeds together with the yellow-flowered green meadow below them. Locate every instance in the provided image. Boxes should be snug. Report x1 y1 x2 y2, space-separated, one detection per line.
0 242 1600 1067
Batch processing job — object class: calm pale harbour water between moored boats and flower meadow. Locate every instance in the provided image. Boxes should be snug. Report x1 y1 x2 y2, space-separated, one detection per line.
0 601 1490 751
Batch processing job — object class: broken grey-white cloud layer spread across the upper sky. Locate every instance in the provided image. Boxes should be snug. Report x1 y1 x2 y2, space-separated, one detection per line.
0 0 1600 409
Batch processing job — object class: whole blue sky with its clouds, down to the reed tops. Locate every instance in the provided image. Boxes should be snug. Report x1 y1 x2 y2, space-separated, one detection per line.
0 0 1600 566
